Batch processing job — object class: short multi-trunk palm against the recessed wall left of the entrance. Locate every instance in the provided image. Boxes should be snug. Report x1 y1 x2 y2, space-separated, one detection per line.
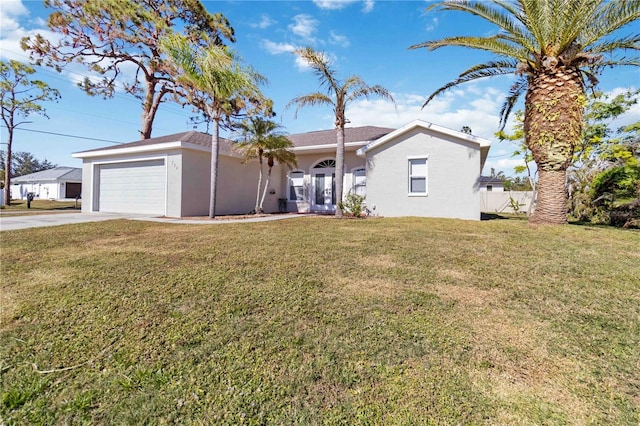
238 117 297 213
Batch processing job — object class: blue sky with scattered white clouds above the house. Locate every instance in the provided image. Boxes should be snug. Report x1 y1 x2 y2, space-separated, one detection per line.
0 0 640 175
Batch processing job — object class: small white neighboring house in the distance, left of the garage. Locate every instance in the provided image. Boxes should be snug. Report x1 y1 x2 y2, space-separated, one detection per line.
11 167 82 200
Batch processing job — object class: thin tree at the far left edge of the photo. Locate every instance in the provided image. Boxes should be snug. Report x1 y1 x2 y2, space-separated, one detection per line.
0 60 60 205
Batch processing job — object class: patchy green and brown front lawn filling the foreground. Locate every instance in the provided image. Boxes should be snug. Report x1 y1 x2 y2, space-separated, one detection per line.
0 218 640 425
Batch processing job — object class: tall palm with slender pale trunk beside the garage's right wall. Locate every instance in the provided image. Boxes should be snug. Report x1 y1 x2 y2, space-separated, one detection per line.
162 34 266 219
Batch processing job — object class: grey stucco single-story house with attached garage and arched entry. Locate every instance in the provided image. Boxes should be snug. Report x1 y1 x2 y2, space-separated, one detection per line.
73 120 490 220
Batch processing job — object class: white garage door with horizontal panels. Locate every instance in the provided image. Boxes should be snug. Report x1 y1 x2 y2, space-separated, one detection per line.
98 160 166 215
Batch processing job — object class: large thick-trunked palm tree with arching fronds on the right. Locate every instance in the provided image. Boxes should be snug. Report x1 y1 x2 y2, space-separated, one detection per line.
410 0 640 224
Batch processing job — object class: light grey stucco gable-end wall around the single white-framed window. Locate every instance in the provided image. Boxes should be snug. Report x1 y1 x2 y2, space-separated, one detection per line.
366 129 480 220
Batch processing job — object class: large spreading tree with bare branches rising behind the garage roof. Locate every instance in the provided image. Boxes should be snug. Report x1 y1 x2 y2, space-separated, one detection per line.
22 0 235 139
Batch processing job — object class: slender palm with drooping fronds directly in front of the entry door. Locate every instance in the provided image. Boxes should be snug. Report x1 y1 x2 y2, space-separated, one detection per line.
287 47 395 217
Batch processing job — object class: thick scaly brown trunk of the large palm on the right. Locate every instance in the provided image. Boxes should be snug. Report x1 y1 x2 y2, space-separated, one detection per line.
524 67 586 224
